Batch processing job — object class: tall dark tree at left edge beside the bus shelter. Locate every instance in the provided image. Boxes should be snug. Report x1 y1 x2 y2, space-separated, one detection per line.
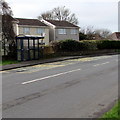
0 0 16 55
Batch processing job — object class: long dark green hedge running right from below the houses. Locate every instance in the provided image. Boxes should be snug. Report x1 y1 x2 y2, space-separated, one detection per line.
52 39 120 52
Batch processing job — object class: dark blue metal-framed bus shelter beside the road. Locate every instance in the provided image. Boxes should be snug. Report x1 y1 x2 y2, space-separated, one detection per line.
16 36 45 61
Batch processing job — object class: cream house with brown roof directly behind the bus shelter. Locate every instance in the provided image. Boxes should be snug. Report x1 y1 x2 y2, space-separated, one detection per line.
14 18 49 45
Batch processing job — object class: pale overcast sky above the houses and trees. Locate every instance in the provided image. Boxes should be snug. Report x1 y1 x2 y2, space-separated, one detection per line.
6 0 119 32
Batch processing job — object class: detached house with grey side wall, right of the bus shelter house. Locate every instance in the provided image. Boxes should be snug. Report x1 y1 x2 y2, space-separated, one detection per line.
41 19 79 42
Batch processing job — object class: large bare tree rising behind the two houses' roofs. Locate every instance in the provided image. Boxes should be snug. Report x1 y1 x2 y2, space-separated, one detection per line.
38 6 78 25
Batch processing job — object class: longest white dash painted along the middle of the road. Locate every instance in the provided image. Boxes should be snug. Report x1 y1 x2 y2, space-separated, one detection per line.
21 69 81 85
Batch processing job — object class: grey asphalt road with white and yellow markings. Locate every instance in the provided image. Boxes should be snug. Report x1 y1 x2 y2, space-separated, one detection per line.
2 55 118 118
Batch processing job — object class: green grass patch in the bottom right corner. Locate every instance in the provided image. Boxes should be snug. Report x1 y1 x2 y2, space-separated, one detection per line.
102 101 120 120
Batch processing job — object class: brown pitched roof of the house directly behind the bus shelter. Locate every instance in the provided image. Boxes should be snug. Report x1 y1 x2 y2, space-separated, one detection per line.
16 18 47 26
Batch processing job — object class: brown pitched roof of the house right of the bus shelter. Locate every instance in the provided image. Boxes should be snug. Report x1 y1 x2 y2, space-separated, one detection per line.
46 20 78 28
